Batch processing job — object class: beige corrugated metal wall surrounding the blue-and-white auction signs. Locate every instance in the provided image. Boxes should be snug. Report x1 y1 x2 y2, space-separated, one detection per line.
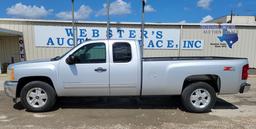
0 20 256 67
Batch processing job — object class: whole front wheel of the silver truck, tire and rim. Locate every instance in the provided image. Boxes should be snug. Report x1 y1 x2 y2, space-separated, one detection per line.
20 81 56 112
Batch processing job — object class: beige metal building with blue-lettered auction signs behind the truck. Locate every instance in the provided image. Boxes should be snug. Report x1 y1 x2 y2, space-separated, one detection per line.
0 19 256 72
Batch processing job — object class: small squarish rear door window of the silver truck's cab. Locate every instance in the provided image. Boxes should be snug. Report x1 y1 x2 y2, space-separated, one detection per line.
113 43 132 63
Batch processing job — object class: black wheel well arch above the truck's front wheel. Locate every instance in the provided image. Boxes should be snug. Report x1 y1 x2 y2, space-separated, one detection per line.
16 76 54 97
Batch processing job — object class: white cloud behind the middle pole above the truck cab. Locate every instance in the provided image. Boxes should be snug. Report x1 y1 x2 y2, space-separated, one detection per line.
96 0 131 16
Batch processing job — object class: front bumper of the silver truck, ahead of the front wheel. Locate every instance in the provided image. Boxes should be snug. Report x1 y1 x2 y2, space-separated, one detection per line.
4 81 18 99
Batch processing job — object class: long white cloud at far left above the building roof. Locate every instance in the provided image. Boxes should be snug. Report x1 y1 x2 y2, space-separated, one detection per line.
6 3 53 19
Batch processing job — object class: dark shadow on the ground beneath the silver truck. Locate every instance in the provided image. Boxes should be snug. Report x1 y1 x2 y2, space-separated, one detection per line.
14 96 238 111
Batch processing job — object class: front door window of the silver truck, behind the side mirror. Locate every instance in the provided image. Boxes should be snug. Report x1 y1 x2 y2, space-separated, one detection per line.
73 43 106 63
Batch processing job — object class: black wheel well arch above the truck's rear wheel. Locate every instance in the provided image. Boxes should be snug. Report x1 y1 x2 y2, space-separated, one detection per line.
182 74 221 93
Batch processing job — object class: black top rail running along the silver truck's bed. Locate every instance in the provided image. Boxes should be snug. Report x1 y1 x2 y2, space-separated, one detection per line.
142 56 247 61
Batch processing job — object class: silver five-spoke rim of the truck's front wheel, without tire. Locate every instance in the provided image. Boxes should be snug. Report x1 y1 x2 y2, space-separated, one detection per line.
26 87 48 108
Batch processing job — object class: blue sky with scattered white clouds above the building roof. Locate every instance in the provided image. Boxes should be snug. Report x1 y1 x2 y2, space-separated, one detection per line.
0 0 256 22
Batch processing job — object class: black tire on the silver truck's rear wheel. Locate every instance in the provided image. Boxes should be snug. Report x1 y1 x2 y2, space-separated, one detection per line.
181 82 216 113
